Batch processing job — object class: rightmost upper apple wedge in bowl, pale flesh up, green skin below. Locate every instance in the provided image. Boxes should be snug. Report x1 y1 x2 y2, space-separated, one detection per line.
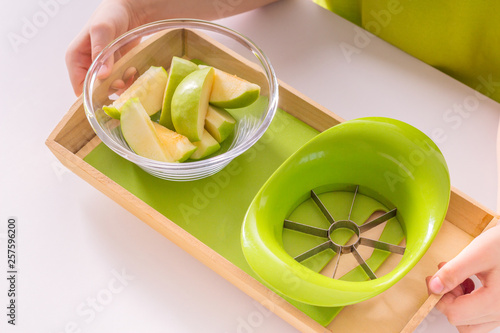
210 69 260 109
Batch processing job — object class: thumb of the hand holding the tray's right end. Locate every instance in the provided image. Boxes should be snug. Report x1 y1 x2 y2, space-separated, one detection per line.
428 241 489 294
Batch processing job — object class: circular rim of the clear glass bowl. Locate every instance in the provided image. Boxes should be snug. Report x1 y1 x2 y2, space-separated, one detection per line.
83 18 279 171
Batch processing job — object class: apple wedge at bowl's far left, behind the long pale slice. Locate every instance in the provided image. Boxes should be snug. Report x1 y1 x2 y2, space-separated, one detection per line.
102 66 168 119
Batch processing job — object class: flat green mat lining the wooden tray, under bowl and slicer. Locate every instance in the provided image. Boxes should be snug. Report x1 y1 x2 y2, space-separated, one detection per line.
84 105 401 326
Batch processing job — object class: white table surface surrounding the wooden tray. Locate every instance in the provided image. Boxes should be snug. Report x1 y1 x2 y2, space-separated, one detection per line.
0 0 500 333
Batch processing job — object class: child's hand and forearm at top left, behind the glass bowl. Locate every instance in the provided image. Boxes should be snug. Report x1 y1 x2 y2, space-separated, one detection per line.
66 0 276 96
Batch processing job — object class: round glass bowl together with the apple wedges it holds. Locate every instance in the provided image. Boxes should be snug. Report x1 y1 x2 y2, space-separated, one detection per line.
83 19 279 181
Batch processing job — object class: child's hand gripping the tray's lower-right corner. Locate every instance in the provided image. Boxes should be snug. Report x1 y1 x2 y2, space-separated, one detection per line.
427 226 500 333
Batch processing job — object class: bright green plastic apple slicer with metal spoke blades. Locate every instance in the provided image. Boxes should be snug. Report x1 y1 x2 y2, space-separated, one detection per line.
242 118 450 307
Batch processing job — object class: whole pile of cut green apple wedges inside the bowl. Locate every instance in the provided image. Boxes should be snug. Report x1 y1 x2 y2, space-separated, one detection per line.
103 56 260 163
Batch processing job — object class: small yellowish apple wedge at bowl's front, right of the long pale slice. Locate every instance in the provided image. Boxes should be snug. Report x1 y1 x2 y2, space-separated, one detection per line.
153 122 198 162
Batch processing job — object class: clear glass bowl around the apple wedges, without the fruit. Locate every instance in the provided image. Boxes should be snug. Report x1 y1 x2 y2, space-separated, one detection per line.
83 19 278 181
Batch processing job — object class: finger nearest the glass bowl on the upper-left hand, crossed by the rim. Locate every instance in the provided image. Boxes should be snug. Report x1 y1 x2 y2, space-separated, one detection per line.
89 23 116 79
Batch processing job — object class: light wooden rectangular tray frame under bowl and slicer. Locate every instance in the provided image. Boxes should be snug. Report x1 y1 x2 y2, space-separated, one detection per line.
46 30 498 332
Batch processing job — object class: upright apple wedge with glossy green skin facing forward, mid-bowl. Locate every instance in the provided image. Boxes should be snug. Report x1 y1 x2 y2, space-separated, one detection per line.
171 67 214 142
